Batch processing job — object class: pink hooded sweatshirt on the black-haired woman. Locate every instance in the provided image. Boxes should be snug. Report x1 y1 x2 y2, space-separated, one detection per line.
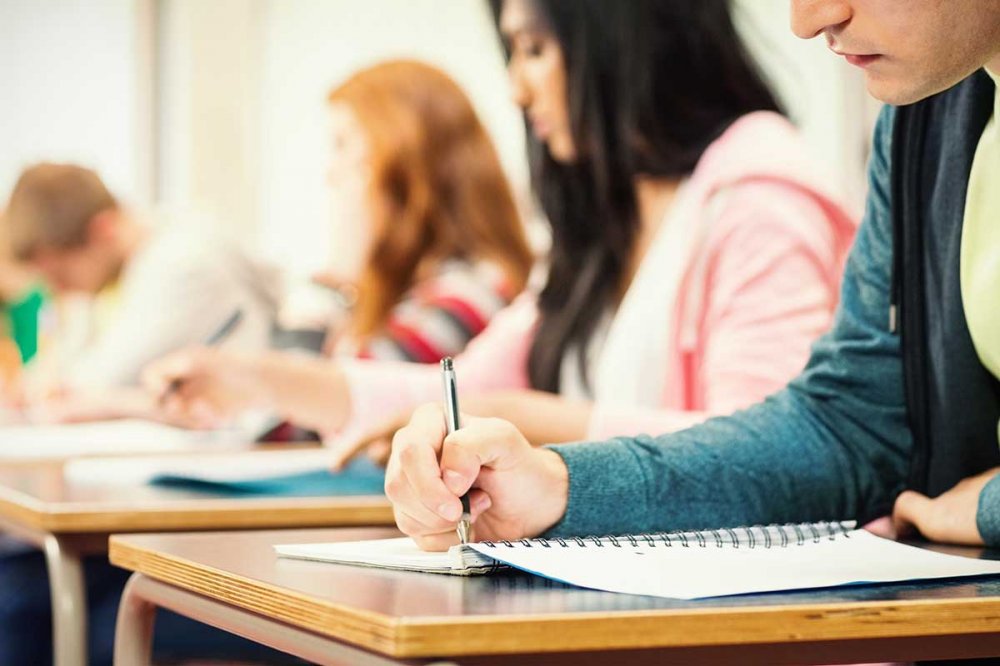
330 112 857 439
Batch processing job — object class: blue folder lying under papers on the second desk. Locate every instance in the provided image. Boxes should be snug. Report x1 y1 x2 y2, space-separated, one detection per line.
150 458 385 497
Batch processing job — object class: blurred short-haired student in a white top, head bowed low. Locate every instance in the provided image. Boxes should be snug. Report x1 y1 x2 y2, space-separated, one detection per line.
2 164 278 400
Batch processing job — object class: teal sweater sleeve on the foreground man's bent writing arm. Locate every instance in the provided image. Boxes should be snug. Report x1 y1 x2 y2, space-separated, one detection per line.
551 109 916 534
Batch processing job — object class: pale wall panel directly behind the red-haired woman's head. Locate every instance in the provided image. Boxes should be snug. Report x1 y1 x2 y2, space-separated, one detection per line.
260 0 527 274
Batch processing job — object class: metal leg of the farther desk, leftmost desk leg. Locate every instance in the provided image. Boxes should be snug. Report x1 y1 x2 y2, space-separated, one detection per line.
43 534 87 666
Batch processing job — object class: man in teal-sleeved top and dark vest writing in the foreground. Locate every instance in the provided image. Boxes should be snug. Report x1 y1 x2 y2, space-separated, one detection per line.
386 0 1000 549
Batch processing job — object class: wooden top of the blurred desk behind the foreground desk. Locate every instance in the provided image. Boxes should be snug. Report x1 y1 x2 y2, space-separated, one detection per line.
0 450 393 534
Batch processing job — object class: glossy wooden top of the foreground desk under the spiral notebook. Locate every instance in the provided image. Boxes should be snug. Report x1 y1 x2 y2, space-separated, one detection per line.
110 528 1000 663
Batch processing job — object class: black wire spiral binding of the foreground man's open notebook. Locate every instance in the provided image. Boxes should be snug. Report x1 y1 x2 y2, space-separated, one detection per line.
483 520 855 548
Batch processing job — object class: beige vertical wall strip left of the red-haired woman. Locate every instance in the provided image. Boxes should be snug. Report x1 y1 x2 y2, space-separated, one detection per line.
156 0 266 236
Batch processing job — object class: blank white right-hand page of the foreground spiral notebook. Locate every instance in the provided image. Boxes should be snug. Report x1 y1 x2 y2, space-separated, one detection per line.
470 530 1000 599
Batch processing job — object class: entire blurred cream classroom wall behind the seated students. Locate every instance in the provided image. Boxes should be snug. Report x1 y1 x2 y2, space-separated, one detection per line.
0 0 877 275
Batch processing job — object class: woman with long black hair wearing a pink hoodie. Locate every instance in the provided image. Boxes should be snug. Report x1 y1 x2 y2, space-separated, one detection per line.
149 0 854 458
